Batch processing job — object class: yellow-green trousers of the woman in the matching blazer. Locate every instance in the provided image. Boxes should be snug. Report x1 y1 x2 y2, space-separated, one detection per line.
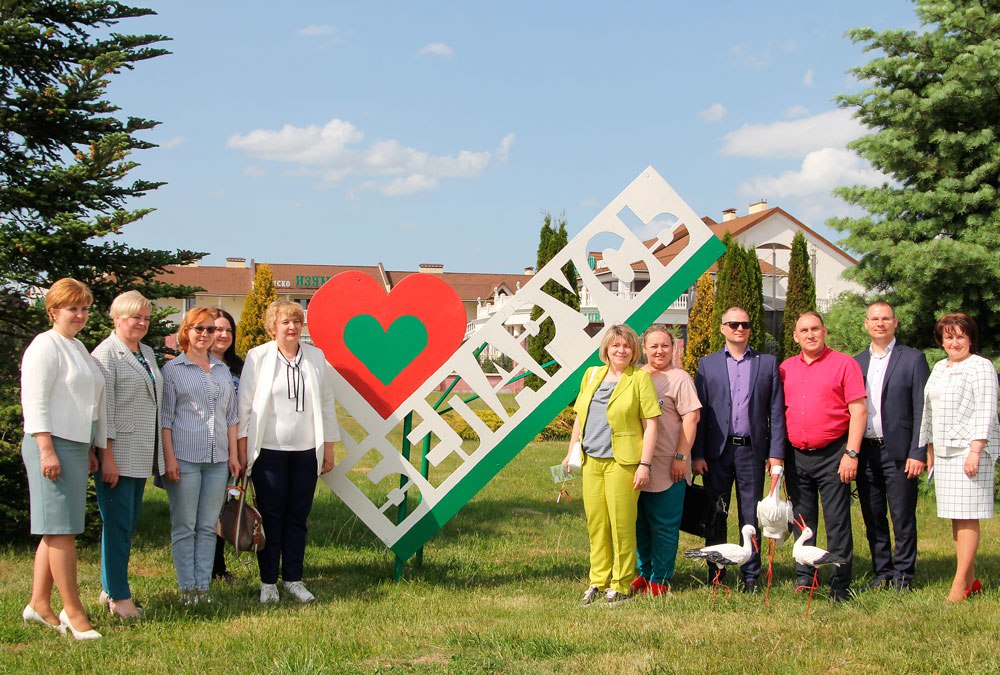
583 456 639 593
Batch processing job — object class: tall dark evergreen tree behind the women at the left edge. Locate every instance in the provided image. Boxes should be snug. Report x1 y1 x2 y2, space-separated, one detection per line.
0 0 203 374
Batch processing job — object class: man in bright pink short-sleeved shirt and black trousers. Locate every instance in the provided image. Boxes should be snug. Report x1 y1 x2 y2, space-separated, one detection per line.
779 312 868 600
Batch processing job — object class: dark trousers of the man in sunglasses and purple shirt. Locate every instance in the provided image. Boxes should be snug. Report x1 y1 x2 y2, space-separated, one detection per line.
705 443 764 580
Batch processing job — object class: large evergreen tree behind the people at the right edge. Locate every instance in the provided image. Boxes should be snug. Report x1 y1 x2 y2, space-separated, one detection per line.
830 0 1000 353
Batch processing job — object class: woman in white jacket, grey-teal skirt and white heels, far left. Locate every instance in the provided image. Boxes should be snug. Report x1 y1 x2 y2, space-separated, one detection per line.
21 279 107 640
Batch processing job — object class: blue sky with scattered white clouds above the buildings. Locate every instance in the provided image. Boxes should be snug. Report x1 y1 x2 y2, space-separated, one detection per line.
109 0 919 272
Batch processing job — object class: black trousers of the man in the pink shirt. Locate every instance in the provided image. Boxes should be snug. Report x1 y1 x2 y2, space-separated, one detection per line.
785 434 854 592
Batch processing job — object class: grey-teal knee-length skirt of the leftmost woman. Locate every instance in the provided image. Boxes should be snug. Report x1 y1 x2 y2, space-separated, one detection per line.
21 434 90 535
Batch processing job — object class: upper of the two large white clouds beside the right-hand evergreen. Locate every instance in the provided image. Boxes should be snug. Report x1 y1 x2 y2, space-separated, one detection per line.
722 108 865 158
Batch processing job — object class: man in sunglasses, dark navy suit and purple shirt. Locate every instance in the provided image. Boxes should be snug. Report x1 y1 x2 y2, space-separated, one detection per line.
691 307 785 592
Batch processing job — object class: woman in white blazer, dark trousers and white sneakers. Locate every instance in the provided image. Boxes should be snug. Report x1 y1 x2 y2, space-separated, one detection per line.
238 300 340 603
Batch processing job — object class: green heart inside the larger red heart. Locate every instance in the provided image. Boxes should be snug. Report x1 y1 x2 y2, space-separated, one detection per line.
344 314 427 386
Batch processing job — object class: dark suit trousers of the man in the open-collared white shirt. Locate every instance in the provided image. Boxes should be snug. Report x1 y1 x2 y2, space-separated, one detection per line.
858 438 920 586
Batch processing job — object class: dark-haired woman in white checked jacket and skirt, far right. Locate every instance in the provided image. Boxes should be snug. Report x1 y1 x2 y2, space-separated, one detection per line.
919 313 1000 603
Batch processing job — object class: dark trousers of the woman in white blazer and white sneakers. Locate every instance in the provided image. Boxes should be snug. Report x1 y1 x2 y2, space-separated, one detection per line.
250 448 317 584
